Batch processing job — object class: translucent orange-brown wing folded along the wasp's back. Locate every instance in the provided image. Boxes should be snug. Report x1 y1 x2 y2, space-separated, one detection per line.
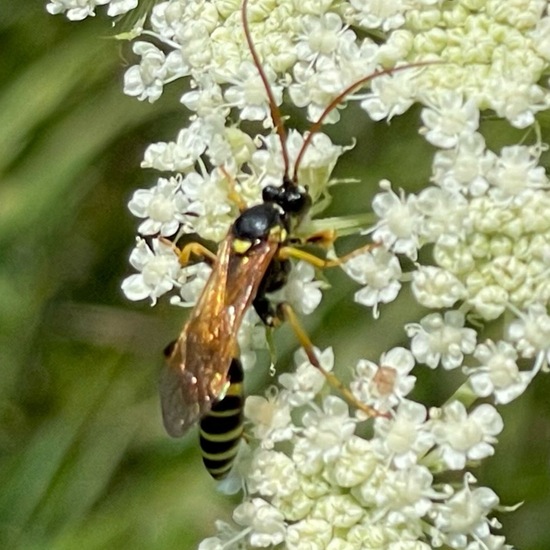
160 234 280 437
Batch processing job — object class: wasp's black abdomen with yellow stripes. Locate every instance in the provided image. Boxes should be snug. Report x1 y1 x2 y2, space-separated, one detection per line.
199 358 244 479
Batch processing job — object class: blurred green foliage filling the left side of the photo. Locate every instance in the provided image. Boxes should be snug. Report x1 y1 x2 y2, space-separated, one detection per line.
0 1 235 550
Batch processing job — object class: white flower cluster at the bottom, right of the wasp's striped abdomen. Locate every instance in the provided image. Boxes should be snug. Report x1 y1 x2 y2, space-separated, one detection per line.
200 348 511 550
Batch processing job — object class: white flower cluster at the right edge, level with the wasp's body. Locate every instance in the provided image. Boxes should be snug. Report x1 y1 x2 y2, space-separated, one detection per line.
345 101 550 403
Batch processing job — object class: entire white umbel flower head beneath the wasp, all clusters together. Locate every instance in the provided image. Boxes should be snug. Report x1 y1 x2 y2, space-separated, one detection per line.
47 0 550 550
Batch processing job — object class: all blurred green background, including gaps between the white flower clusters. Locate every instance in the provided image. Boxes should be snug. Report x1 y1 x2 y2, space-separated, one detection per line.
0 0 550 550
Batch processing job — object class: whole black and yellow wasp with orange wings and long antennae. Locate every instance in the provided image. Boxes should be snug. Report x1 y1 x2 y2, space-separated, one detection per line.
160 0 434 478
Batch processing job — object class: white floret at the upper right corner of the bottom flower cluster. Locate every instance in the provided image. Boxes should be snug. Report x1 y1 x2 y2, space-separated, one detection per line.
432 401 504 470
